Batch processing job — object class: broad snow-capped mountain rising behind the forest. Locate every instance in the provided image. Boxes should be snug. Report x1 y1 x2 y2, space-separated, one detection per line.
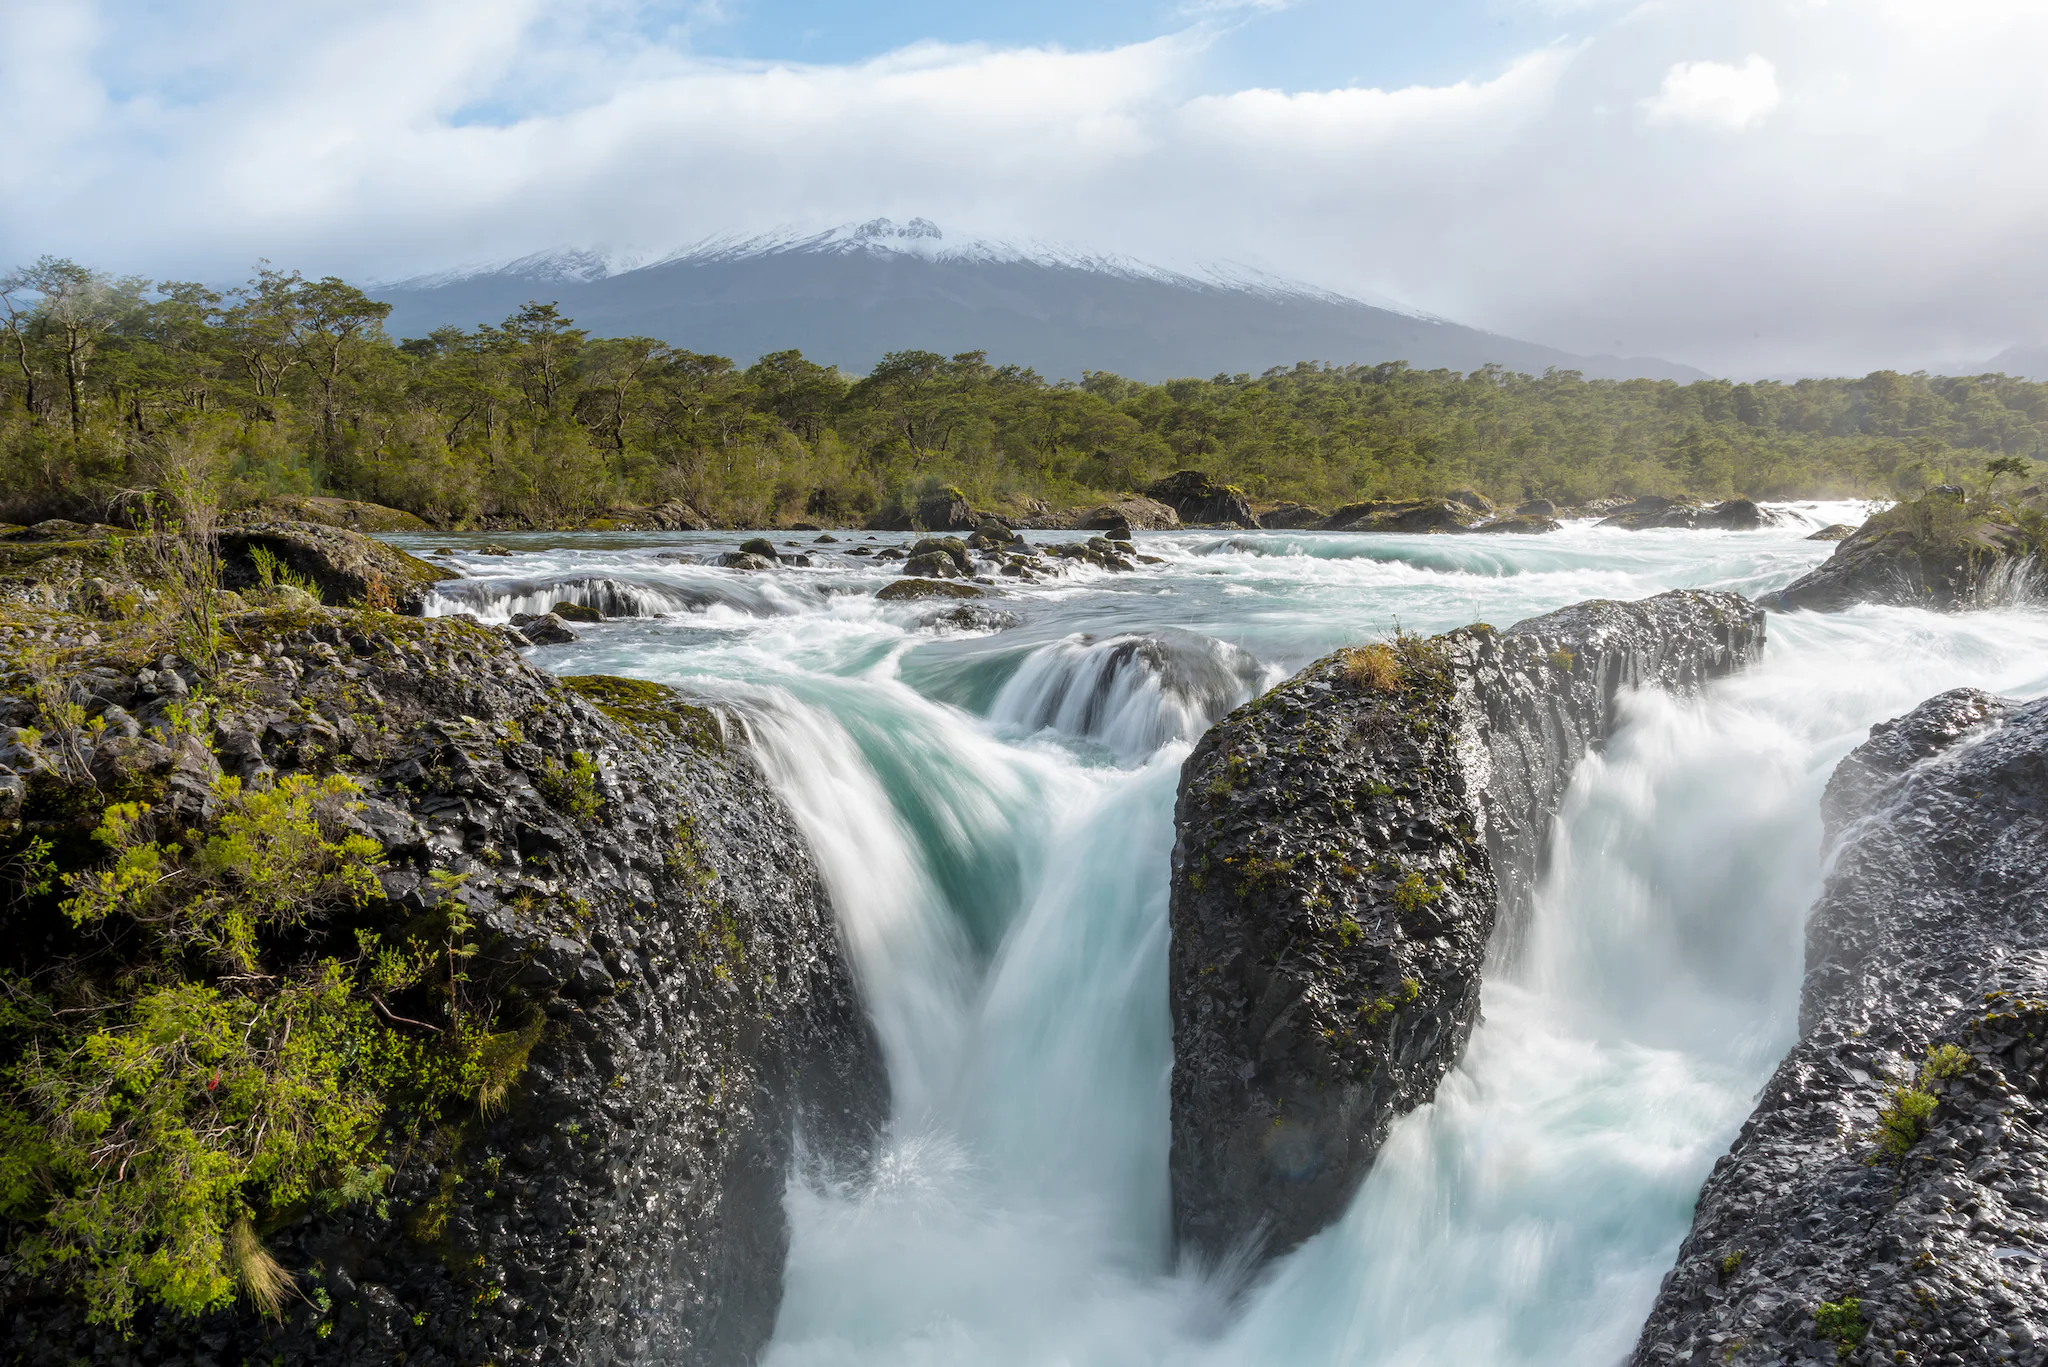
373 217 1700 379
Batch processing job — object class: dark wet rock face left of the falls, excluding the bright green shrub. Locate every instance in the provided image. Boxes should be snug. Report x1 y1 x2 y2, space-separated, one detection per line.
0 607 887 1367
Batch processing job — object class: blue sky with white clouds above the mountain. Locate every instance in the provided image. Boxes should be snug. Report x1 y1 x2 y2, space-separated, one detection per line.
0 0 2048 375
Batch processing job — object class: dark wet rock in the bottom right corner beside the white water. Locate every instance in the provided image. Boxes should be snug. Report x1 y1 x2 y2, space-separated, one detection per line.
1634 689 2048 1367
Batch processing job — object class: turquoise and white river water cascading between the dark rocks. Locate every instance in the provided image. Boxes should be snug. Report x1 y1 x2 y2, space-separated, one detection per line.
399 508 2048 1367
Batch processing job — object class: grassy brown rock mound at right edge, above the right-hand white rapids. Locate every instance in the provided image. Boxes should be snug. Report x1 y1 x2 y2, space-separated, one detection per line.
1769 490 2048 613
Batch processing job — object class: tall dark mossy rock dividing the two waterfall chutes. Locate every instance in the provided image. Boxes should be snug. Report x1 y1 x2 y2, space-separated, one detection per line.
1169 590 1763 1256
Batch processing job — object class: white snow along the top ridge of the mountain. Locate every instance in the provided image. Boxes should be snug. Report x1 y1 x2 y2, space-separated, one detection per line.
377 217 1444 322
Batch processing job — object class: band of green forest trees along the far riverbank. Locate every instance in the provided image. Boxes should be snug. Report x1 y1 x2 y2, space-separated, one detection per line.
0 256 2048 527
